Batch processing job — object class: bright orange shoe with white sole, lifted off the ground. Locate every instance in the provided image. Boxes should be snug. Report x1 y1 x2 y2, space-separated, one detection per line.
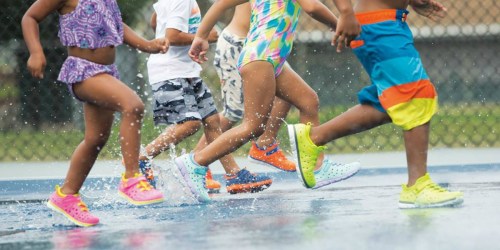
248 142 296 172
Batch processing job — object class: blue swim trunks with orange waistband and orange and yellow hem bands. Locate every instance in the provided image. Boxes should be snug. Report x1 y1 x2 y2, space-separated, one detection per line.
351 9 438 130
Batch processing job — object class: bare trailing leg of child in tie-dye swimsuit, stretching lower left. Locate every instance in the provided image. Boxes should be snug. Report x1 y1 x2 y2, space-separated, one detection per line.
194 61 276 166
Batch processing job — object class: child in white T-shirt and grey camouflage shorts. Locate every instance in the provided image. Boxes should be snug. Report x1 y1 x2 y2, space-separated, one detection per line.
140 0 272 194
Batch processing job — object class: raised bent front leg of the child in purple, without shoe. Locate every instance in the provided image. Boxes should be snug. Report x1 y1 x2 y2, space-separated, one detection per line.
73 74 144 178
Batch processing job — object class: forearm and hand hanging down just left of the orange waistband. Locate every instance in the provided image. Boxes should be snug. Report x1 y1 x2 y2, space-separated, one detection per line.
332 0 361 52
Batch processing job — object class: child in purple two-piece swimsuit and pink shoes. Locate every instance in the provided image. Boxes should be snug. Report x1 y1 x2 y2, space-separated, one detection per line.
22 0 168 226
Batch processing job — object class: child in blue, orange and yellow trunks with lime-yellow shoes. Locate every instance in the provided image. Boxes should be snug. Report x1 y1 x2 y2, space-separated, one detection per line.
288 0 463 208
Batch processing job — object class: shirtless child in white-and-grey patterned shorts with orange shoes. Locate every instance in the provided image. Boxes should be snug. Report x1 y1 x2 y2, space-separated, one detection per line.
196 3 295 174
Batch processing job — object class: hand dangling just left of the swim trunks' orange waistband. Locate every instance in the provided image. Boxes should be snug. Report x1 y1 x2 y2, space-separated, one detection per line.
332 12 361 52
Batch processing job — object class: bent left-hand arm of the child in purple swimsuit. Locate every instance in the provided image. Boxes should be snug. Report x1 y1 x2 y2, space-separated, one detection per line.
21 0 65 79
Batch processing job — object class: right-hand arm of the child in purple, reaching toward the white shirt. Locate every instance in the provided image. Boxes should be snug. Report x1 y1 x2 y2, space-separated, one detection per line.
123 23 169 53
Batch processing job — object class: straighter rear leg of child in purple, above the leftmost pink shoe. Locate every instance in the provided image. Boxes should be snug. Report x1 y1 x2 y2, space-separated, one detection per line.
61 103 114 194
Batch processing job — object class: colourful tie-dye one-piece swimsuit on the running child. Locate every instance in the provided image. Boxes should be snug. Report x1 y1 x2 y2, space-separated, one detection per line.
238 0 301 76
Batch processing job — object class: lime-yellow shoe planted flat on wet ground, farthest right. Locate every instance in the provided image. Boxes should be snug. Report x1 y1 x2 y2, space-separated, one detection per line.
399 173 464 208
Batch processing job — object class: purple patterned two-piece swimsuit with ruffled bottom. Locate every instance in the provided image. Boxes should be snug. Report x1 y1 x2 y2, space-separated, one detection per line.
57 0 123 100
